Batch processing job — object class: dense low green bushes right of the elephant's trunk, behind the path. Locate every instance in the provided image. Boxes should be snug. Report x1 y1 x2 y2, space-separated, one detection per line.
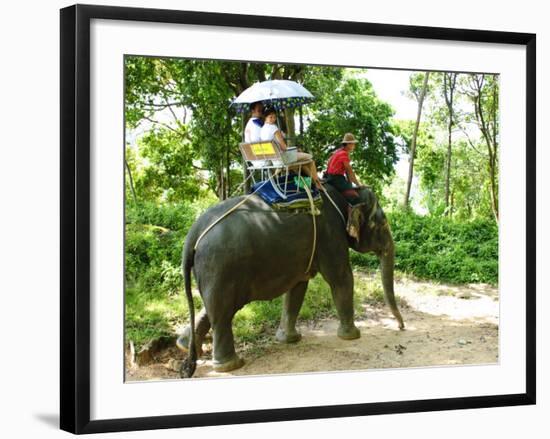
350 211 498 284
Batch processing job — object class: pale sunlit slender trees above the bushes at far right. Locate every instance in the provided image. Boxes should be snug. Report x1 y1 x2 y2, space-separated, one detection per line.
410 72 498 220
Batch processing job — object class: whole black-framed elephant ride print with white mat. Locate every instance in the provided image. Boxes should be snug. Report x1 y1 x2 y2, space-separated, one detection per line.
61 5 536 433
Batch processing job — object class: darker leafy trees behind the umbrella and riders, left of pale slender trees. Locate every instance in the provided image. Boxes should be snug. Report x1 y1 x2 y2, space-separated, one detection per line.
125 56 397 201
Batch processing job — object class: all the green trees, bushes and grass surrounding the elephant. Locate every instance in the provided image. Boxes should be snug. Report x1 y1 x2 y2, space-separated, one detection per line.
125 56 499 346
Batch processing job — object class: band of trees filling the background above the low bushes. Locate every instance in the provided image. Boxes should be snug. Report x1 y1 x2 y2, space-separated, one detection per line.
125 56 498 220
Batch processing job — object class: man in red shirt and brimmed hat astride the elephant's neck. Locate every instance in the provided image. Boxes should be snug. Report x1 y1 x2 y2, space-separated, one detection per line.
326 133 361 205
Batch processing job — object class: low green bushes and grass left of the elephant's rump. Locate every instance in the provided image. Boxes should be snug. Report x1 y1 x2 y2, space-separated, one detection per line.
125 196 216 346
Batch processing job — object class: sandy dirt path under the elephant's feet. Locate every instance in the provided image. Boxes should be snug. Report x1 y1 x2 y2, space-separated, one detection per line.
126 274 499 381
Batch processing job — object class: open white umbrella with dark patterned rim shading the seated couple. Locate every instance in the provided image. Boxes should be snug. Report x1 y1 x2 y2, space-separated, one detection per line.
231 79 315 112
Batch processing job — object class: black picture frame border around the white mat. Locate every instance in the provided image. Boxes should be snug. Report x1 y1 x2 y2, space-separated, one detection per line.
60 5 536 434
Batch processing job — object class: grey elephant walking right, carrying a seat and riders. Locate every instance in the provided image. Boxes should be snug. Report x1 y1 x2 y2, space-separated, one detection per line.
177 184 404 377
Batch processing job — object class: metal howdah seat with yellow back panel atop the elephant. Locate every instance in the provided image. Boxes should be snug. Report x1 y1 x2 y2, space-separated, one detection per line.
239 141 312 199
